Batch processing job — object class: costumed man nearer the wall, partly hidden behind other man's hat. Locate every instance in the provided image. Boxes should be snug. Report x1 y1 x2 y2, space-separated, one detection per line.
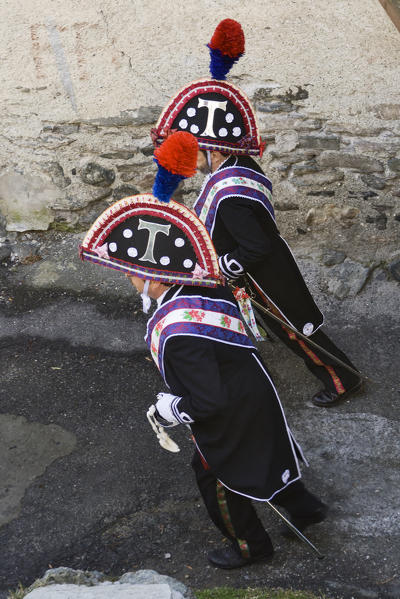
152 19 362 406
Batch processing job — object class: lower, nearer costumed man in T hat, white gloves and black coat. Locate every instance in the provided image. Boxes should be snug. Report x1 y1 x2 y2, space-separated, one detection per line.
80 132 326 569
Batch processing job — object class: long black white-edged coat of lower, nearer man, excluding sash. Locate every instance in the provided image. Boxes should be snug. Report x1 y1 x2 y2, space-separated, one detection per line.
158 287 301 500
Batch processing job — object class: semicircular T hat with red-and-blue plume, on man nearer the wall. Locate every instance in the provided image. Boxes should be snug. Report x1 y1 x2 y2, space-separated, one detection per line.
151 19 265 156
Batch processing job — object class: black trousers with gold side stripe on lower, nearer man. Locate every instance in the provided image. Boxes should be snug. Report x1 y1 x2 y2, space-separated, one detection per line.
192 450 323 557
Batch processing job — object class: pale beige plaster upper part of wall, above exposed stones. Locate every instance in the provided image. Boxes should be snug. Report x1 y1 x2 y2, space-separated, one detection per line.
0 0 400 120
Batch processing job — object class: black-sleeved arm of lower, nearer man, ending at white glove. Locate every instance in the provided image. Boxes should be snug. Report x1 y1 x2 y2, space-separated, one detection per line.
165 335 228 423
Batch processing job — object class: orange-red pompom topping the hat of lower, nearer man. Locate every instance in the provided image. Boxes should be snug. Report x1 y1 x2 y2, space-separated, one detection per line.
154 131 199 177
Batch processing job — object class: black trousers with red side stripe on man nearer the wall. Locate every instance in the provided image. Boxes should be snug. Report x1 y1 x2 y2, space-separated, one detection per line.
252 286 360 395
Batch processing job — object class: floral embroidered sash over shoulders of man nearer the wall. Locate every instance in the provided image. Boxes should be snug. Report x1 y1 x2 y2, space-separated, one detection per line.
193 167 275 236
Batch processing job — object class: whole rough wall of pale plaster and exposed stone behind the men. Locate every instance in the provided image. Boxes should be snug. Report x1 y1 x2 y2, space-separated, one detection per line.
0 0 400 286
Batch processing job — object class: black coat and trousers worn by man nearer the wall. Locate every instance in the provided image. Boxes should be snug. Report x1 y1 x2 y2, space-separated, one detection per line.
194 156 360 395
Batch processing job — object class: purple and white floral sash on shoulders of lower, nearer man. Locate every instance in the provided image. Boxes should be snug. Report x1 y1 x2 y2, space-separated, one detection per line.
145 296 254 380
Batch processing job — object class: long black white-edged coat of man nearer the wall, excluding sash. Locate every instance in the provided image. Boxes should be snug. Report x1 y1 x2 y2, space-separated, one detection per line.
205 156 323 334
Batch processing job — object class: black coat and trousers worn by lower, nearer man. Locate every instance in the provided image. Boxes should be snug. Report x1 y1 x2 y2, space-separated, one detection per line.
147 286 322 558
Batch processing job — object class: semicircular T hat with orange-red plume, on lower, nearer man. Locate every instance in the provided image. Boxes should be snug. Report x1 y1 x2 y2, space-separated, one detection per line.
80 132 223 287
